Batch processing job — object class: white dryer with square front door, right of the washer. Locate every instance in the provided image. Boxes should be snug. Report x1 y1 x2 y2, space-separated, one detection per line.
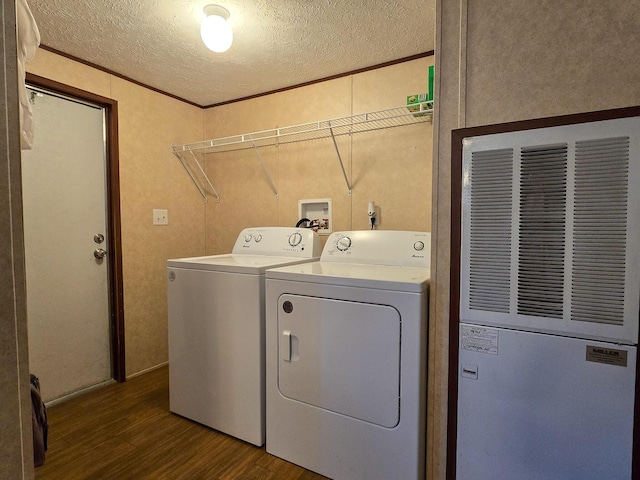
266 231 431 480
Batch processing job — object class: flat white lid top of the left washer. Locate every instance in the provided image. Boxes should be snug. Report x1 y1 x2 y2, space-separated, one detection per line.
167 253 318 275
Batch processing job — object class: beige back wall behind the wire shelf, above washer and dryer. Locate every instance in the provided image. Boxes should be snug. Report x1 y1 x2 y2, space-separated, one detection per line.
205 57 433 254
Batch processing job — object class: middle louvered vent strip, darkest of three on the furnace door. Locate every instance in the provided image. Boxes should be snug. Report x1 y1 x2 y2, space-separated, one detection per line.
518 144 568 319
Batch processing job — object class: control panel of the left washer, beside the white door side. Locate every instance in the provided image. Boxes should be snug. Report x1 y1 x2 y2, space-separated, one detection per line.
232 227 322 258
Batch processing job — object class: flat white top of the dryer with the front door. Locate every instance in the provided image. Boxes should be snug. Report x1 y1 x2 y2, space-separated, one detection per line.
265 262 431 293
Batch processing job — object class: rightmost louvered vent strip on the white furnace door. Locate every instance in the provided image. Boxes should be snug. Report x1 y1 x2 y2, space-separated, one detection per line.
571 137 629 325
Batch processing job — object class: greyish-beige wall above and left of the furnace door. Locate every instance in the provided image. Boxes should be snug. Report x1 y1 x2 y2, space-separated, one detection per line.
427 0 640 480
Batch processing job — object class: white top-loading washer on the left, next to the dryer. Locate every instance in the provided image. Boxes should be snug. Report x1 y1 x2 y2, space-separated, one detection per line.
167 227 322 446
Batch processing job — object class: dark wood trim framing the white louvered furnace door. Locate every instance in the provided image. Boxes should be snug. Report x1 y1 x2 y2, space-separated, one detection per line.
446 106 640 480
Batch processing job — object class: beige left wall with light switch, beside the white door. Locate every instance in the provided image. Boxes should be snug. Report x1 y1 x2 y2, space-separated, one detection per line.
28 50 205 376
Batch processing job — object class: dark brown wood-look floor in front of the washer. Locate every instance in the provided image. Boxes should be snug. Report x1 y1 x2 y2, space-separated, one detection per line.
36 367 325 480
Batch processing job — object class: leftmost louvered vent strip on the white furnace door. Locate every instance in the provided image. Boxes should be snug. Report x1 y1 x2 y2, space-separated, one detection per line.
469 149 513 313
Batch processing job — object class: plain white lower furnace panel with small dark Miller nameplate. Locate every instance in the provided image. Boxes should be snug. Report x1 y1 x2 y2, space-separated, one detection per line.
456 323 637 480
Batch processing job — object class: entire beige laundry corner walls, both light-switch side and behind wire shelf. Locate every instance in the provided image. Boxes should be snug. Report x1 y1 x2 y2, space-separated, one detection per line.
28 50 433 376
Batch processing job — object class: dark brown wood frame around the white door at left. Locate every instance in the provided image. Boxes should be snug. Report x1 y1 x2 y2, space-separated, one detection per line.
26 73 126 382
